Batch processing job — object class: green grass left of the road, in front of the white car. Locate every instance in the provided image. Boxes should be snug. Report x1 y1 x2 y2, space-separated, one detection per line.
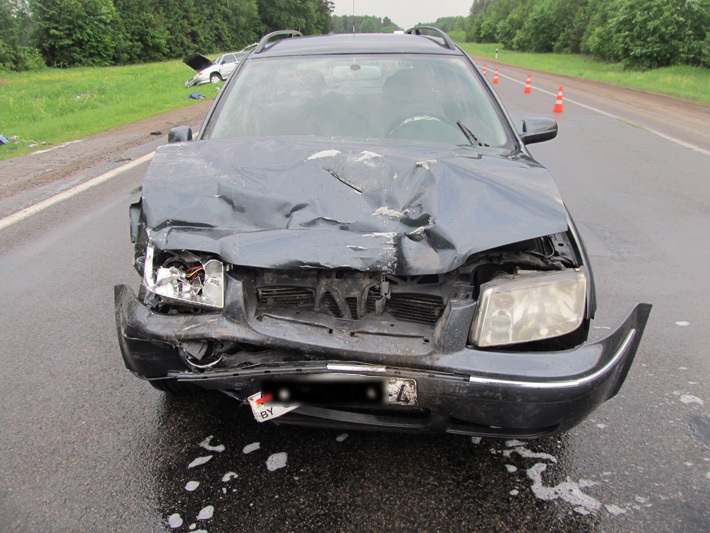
0 60 221 161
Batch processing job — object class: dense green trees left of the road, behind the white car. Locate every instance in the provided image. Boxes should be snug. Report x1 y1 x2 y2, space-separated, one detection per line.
0 0 332 70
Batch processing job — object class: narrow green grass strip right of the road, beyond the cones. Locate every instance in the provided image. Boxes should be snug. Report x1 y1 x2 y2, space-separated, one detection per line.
458 43 710 104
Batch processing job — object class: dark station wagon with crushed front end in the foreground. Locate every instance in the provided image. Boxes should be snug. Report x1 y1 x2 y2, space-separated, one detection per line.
115 27 651 438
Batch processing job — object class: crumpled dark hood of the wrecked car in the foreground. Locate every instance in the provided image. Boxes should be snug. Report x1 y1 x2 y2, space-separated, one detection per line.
143 139 567 275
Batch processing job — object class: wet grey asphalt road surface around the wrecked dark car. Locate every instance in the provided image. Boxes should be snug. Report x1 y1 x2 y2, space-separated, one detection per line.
0 68 710 532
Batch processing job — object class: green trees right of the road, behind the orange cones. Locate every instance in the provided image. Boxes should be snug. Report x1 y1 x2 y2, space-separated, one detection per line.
466 0 710 69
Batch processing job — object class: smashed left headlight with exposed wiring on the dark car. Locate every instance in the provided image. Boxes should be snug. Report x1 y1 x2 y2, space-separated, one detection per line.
143 244 224 309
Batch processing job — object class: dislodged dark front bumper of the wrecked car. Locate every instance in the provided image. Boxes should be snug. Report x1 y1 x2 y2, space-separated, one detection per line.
115 283 651 438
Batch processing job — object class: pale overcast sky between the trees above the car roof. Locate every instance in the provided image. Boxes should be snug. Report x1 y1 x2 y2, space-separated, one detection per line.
334 0 473 30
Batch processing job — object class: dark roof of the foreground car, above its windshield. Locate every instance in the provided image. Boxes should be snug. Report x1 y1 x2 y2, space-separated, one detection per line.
250 33 463 59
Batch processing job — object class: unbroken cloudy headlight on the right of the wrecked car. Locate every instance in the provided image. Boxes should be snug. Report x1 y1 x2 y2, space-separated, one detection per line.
470 270 587 347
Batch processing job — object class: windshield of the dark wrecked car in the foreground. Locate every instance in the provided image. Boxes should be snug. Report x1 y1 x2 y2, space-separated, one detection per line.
205 54 513 147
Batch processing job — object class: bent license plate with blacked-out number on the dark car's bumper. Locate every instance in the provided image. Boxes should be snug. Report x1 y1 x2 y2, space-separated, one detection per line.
249 375 417 422
